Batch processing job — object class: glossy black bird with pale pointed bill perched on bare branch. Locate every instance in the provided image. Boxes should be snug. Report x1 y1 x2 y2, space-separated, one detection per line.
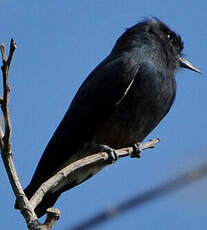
16 18 200 217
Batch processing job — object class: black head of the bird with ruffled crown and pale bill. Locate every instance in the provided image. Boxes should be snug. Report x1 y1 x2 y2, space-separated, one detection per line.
112 18 201 73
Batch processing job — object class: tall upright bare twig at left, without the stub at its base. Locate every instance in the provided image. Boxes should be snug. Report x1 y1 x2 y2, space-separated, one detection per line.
0 39 40 225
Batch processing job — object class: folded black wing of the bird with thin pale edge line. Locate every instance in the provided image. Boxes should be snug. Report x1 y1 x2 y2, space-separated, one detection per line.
28 55 139 187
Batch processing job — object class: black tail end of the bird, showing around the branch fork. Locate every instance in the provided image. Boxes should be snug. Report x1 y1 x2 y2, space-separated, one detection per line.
15 185 61 218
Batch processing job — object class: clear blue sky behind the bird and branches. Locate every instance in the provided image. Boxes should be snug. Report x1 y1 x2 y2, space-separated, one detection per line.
0 0 207 230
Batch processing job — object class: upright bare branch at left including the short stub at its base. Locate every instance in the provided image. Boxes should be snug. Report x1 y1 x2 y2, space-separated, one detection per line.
0 39 60 230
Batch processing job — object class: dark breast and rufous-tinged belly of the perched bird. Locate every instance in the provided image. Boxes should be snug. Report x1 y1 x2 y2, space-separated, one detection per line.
95 70 176 149
